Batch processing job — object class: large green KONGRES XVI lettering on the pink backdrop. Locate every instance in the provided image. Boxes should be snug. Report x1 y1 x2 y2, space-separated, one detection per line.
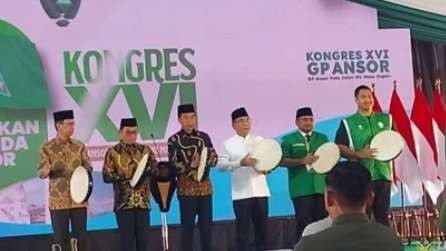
63 48 197 142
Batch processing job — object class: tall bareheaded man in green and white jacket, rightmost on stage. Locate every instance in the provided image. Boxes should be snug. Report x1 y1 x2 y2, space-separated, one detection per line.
335 85 392 226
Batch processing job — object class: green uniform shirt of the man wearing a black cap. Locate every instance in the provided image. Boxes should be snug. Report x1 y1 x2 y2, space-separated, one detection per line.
281 131 328 198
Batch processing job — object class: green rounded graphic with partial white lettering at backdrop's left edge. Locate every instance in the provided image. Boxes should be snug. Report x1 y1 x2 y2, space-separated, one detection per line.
0 20 49 189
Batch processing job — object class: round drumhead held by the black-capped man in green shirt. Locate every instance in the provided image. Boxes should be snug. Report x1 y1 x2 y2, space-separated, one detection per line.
311 143 341 173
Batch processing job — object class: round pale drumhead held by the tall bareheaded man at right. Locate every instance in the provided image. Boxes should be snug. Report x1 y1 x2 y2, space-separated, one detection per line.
370 130 404 161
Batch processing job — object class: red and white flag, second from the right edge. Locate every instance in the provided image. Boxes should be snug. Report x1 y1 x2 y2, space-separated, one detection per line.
411 82 443 204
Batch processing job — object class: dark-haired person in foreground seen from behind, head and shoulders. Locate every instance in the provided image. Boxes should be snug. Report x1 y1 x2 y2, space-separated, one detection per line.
294 161 403 251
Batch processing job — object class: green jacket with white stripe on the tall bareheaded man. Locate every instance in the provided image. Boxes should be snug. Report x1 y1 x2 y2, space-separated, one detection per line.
335 112 392 181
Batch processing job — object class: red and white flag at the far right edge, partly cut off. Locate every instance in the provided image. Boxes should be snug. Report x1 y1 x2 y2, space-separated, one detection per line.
432 80 446 181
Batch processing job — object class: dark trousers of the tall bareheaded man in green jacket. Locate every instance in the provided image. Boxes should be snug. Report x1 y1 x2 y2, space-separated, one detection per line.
367 180 392 226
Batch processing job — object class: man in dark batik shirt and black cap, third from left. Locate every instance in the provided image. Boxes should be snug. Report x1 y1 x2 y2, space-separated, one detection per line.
167 104 218 251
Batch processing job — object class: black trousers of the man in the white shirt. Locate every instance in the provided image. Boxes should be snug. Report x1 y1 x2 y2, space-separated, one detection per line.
233 197 268 251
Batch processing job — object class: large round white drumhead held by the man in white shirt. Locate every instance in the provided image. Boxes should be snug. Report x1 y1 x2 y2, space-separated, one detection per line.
250 139 282 172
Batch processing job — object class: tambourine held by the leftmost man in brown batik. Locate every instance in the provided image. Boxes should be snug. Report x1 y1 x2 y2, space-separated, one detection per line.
70 166 93 203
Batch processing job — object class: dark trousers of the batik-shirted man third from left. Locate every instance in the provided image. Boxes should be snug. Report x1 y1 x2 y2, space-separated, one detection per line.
178 195 212 251
